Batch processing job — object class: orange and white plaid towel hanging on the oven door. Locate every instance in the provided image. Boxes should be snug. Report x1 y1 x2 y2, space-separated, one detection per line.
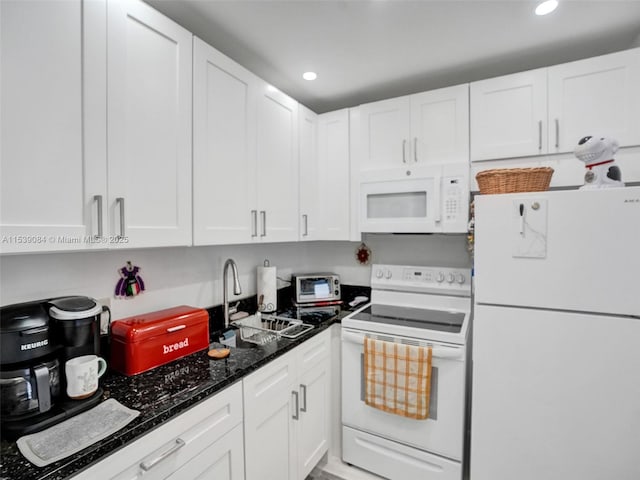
364 337 432 420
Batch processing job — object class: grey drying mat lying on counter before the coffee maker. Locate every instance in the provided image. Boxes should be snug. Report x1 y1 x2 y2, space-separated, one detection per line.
17 398 140 467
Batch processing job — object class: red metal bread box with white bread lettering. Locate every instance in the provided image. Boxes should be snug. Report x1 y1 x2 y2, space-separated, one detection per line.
110 305 209 375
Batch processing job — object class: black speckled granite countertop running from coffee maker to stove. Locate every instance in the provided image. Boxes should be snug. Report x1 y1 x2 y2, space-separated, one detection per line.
0 304 360 480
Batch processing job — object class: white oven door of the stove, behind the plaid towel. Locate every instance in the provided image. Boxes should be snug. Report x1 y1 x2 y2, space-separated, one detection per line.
342 328 466 461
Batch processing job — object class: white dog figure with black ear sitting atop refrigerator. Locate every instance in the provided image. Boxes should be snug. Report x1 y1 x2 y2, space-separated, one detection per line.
573 136 624 190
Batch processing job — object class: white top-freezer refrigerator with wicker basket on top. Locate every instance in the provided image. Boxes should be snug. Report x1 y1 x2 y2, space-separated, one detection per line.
470 187 640 480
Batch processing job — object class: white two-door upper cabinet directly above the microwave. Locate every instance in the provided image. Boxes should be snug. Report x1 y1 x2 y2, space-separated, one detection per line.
359 84 469 171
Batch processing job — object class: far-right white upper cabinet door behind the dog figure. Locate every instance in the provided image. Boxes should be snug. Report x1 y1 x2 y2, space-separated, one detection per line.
549 48 640 153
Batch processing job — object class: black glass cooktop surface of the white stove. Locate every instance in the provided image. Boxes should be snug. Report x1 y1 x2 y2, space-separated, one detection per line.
353 304 465 333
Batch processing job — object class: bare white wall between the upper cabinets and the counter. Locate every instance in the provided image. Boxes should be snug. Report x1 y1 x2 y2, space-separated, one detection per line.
0 235 470 319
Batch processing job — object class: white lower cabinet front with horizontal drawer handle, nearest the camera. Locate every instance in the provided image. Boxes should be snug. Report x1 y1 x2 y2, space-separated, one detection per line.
74 382 244 480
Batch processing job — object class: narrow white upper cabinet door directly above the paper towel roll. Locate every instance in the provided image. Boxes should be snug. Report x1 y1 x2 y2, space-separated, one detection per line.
256 84 299 242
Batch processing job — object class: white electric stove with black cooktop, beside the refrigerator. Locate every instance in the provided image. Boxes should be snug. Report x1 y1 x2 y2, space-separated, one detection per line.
342 265 471 480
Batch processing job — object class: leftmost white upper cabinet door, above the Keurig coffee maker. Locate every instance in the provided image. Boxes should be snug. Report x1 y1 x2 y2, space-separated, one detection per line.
0 0 106 253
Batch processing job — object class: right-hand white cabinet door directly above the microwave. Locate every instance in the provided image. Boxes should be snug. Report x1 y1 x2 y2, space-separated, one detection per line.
409 84 469 164
